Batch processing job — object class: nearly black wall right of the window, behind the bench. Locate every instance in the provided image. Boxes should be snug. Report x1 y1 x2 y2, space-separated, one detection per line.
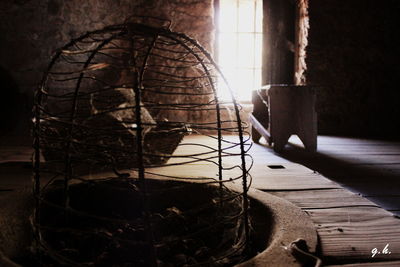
306 0 400 137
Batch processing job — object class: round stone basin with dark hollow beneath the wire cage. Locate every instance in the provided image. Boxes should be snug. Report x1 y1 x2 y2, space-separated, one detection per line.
0 179 317 267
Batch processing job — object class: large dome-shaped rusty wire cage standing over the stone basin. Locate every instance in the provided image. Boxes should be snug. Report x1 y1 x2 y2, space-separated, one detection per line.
32 19 251 266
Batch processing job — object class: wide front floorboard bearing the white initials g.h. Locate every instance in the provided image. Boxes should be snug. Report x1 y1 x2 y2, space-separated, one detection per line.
306 207 400 261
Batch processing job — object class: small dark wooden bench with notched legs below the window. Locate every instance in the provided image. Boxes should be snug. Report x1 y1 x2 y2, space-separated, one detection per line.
250 85 317 152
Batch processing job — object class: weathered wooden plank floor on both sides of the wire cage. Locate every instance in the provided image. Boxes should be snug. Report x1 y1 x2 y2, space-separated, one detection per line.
0 136 400 267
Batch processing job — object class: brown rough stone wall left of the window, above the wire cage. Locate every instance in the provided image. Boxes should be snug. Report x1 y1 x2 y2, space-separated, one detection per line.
0 0 214 134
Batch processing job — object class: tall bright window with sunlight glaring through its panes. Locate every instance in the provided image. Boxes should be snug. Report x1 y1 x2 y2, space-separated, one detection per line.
217 0 262 101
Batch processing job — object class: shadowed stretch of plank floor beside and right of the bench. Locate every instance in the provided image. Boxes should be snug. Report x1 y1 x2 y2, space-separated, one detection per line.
280 136 400 215
